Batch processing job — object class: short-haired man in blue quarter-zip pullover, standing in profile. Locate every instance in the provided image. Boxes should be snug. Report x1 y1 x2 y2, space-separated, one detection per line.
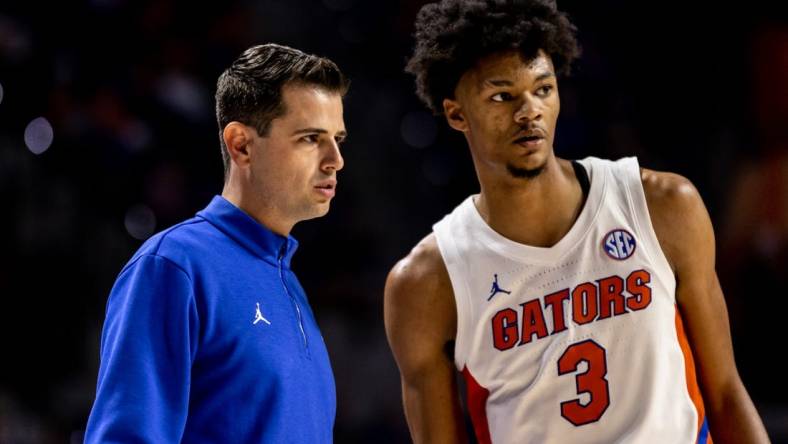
85 44 347 443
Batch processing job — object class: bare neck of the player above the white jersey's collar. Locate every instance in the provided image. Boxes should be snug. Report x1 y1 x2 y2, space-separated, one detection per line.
476 158 584 247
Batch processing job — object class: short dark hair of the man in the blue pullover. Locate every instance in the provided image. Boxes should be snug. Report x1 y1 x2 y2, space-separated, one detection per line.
216 43 349 179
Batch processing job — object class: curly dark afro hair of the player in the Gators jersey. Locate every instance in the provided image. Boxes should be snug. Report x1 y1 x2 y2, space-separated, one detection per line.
406 0 580 114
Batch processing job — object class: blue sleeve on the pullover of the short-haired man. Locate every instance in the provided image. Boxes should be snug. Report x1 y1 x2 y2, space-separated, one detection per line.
85 255 198 443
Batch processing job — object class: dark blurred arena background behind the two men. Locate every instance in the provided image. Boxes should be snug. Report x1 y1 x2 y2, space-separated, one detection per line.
0 0 788 444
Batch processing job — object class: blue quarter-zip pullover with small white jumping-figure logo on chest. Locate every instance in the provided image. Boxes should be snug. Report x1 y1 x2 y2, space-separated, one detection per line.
85 196 336 444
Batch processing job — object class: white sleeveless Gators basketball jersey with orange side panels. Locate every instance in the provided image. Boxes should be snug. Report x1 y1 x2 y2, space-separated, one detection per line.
433 158 710 444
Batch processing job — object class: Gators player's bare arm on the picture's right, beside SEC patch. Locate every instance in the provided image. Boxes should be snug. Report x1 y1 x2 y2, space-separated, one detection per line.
641 169 769 443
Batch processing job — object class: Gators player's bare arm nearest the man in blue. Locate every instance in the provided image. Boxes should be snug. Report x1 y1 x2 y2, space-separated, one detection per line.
384 235 467 444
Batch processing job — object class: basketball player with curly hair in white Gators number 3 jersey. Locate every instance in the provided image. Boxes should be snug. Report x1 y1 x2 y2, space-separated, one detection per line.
385 0 768 444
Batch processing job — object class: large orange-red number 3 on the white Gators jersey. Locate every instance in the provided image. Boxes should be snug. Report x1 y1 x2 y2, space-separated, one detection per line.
558 339 610 426
